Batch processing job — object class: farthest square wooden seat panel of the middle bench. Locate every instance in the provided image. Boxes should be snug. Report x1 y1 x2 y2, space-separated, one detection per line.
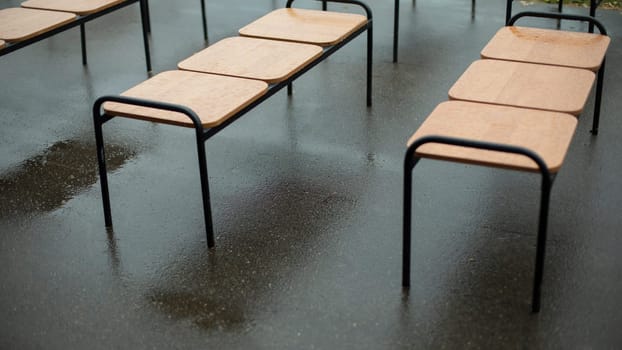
239 8 367 46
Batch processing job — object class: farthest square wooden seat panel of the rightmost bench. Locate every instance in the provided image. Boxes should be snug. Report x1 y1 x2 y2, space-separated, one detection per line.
481 27 611 71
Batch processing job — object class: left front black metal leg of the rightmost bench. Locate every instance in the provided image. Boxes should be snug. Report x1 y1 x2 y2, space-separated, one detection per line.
402 148 417 288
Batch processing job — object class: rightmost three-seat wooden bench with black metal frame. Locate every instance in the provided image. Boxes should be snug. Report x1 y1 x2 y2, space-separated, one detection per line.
402 12 609 313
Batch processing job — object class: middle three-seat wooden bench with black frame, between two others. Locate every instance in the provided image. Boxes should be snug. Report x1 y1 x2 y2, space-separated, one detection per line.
93 0 373 248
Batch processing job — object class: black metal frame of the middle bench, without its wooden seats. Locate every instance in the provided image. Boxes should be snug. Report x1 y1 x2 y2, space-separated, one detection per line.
93 0 373 248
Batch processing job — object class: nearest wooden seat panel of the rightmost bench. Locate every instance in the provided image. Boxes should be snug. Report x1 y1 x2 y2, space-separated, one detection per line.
408 101 577 173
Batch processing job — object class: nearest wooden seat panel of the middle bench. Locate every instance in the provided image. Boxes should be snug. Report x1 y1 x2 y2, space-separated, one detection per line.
104 71 268 127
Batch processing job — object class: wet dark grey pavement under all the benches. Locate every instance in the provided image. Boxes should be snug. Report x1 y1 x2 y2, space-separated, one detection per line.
0 0 622 349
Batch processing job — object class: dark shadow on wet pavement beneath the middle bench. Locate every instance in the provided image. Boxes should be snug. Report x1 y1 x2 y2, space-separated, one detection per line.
103 151 361 330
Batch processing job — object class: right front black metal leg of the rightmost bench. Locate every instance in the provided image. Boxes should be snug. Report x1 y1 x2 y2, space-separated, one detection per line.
531 173 553 313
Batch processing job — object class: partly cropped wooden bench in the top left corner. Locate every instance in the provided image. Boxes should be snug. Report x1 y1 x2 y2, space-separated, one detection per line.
0 0 207 72
